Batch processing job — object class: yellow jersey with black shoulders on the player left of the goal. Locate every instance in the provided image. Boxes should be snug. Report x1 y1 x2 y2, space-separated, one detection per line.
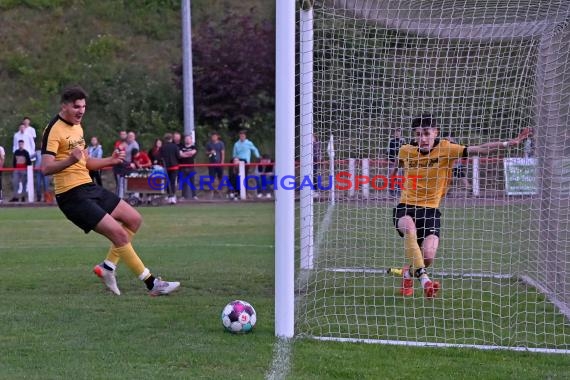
42 115 93 194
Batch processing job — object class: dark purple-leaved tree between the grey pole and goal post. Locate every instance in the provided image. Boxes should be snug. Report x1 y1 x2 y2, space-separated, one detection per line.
174 8 275 131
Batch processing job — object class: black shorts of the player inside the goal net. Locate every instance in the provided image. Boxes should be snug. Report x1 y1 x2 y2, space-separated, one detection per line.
392 203 441 247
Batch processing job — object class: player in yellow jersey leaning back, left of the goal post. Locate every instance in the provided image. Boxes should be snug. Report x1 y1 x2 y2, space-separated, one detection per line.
42 86 180 296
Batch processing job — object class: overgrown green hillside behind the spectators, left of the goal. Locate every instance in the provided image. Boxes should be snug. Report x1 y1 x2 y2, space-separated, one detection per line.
0 0 274 159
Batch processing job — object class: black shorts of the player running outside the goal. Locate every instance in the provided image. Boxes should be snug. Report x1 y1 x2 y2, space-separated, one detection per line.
55 183 121 233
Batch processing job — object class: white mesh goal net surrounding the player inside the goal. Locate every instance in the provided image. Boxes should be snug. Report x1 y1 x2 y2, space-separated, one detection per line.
295 0 570 353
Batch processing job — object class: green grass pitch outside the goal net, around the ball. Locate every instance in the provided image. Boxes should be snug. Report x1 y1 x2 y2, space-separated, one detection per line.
0 203 570 379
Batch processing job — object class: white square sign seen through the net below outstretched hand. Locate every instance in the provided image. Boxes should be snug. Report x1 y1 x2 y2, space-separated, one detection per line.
503 158 538 195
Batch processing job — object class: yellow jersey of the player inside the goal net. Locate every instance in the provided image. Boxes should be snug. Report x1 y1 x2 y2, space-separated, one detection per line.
398 140 467 208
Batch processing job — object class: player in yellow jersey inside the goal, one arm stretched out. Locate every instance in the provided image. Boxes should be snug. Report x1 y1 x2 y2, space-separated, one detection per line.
391 114 529 298
